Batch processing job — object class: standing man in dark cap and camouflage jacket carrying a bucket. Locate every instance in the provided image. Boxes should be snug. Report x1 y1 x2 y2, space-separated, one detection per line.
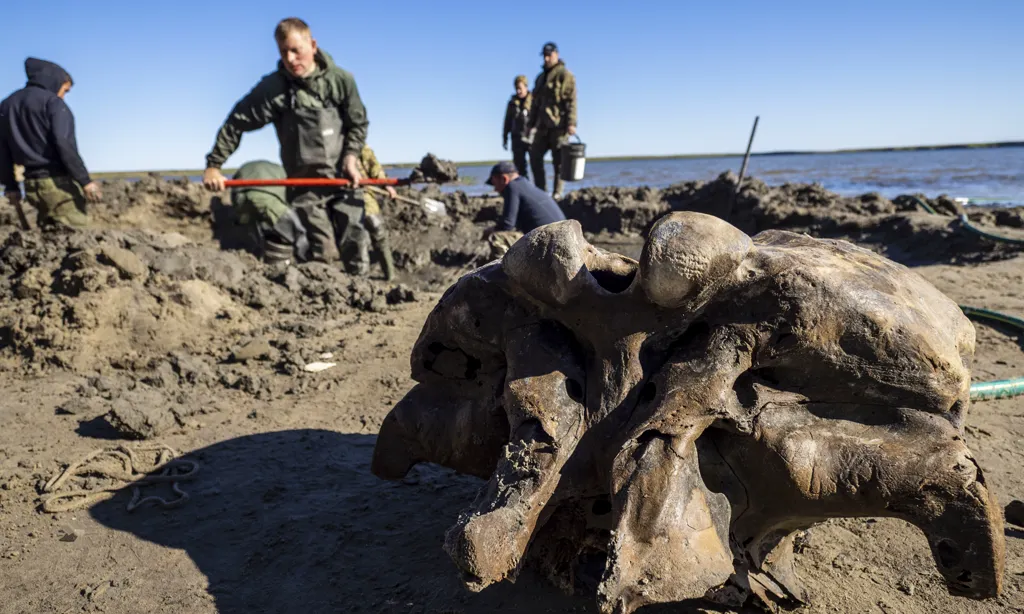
527 43 577 200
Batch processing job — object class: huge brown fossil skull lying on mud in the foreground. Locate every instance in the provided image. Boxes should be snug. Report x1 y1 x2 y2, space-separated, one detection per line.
373 213 1004 613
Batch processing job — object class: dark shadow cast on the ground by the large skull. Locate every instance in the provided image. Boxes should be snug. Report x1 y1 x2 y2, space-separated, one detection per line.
91 430 720 614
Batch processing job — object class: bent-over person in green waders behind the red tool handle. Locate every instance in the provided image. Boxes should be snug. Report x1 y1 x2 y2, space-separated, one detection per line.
231 160 309 264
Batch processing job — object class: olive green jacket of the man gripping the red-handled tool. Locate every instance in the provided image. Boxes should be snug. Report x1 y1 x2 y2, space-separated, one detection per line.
206 49 370 168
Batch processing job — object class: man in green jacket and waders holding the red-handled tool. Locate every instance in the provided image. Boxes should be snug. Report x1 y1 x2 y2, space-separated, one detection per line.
203 17 370 274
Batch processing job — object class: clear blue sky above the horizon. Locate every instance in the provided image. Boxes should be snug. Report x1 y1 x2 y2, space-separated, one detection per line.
0 0 1024 171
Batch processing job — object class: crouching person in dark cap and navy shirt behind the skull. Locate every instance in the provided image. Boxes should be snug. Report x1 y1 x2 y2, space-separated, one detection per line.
486 162 565 259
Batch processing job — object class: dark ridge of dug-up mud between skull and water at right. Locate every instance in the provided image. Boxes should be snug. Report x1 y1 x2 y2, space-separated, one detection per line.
561 173 1024 264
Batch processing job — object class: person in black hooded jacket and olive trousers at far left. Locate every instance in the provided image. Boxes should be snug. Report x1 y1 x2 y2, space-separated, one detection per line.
0 57 102 227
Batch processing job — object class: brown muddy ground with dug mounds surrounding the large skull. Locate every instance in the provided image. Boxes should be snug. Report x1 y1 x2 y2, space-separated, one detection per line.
0 175 1024 614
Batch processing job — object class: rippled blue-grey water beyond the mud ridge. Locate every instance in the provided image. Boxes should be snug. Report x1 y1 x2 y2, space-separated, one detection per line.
440 147 1024 206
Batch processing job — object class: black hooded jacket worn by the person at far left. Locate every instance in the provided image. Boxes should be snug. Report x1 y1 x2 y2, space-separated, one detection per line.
0 57 90 191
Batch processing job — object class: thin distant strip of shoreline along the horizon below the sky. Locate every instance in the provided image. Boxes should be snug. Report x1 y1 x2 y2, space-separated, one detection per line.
92 141 1024 179
